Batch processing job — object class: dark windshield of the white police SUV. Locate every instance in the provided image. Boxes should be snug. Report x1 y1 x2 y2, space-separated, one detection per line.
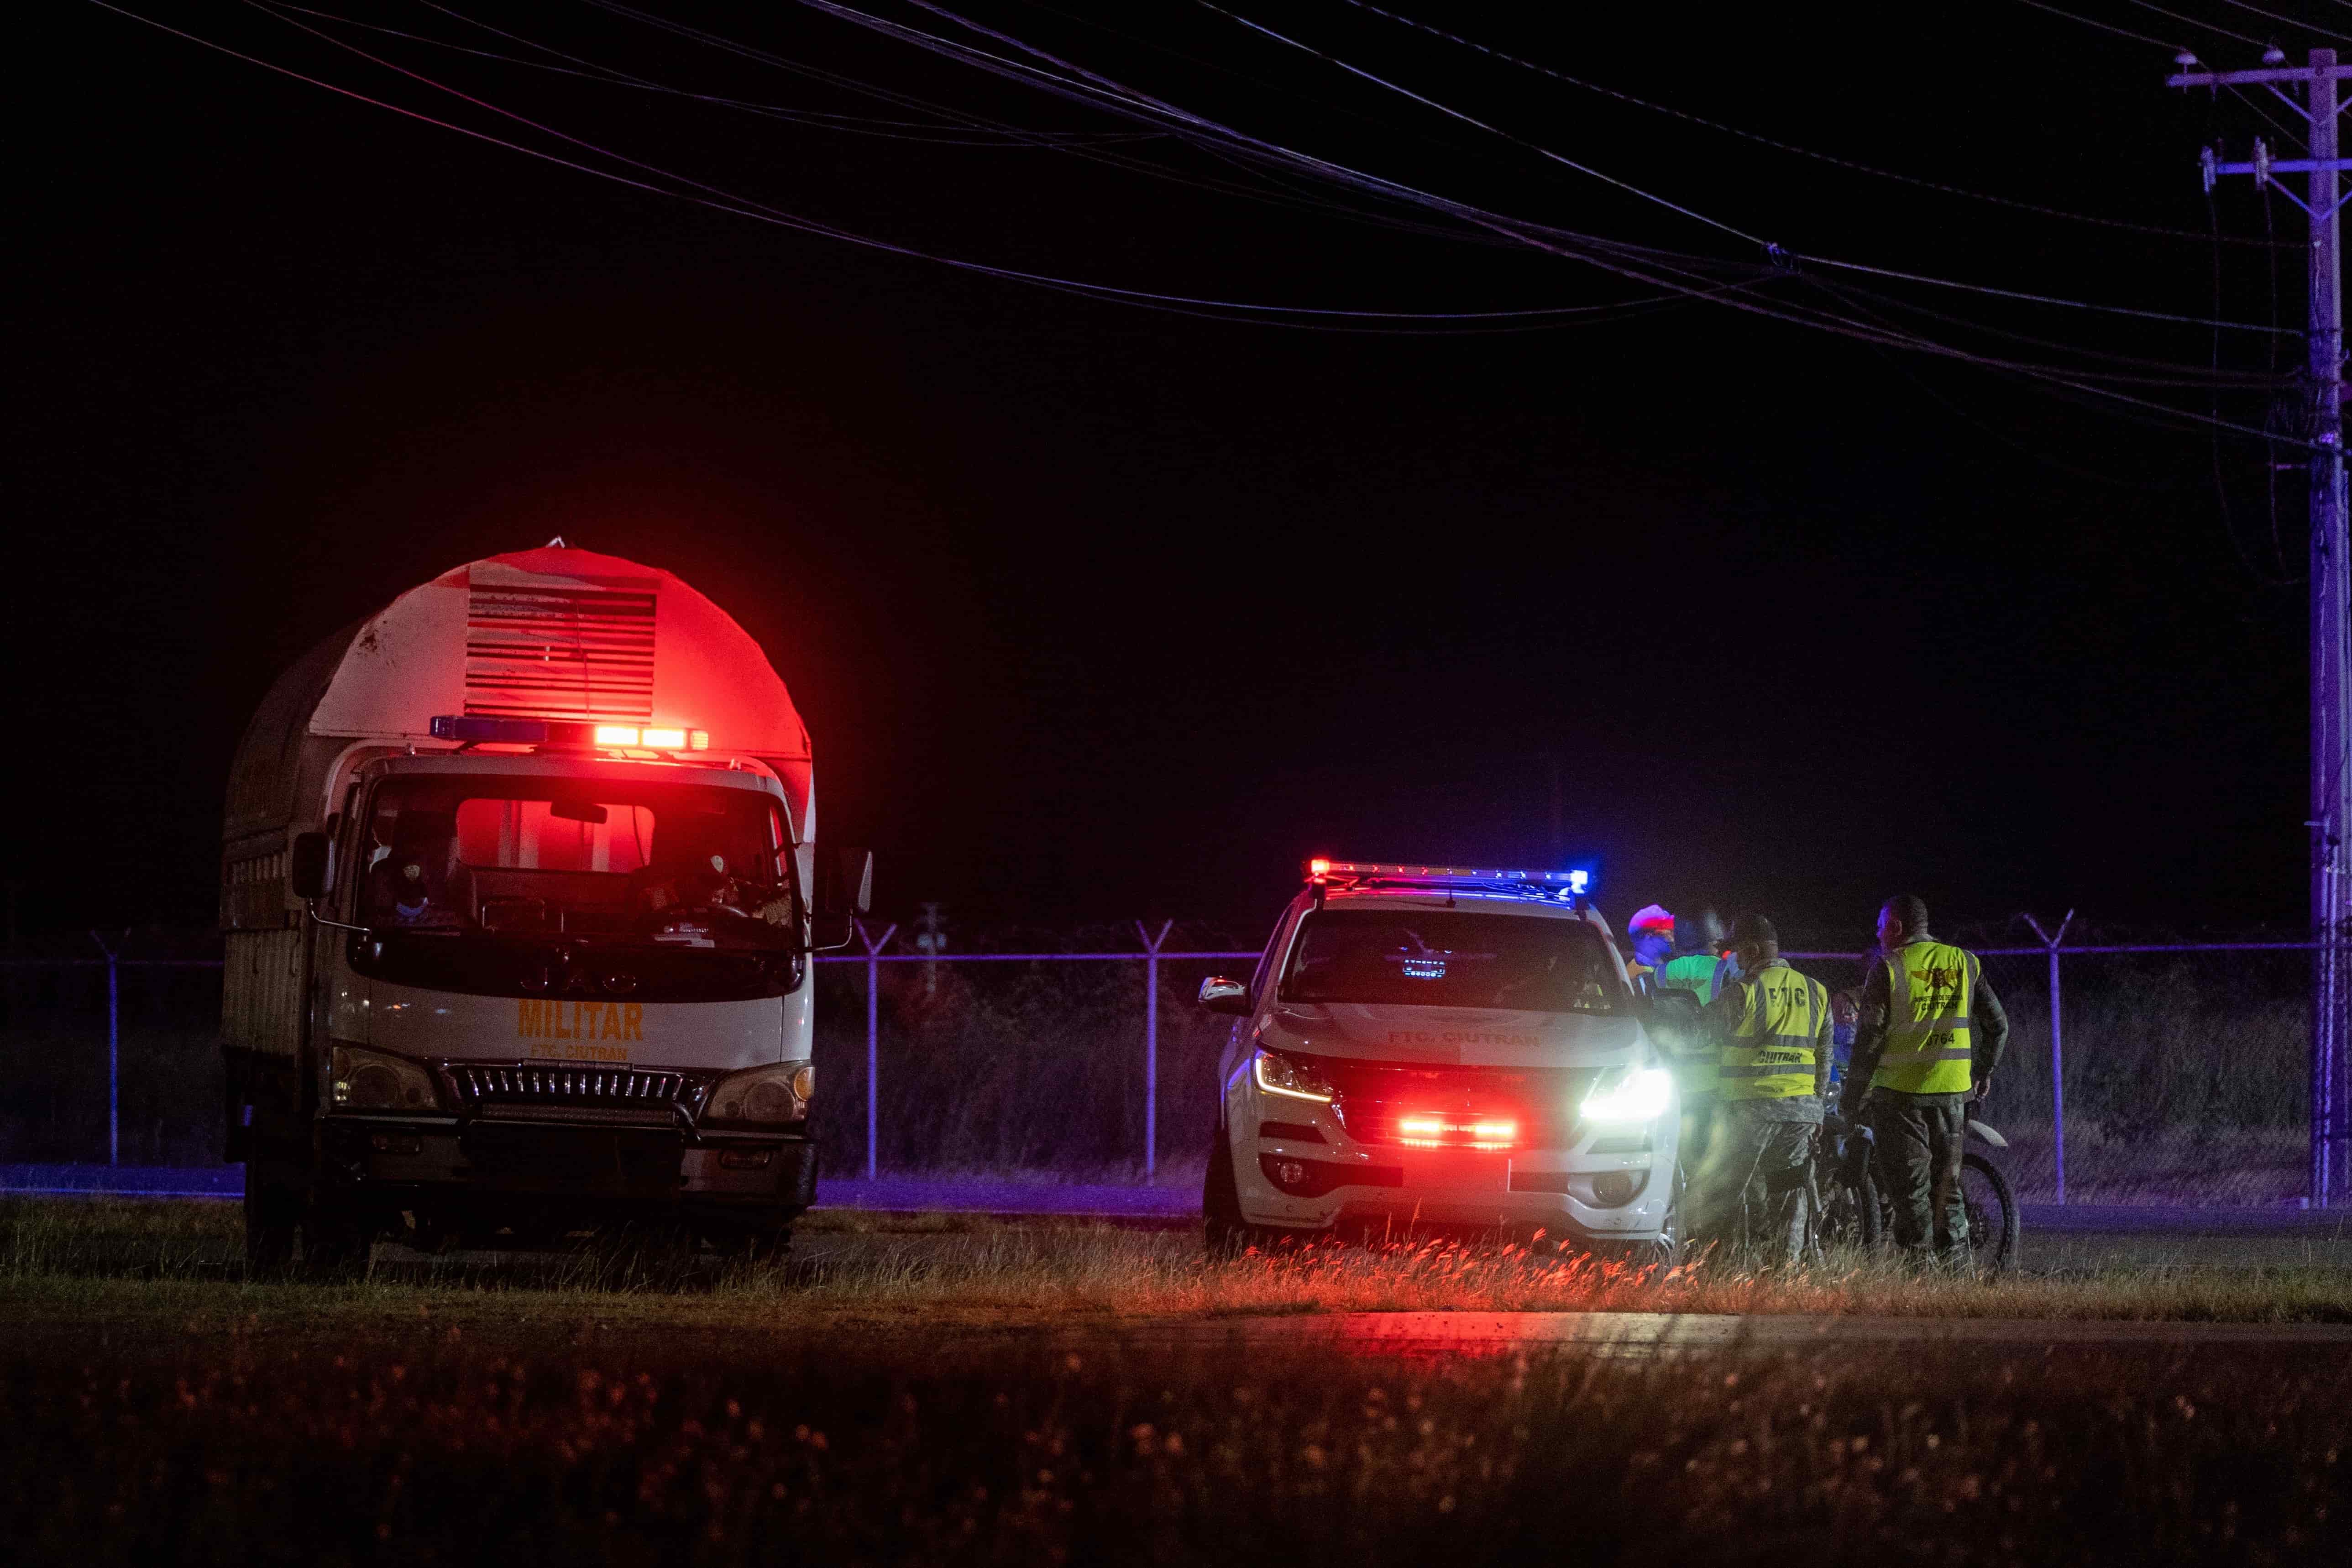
1277 910 1625 1013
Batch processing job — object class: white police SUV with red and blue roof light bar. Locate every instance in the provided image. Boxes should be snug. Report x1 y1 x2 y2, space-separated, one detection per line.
1200 860 1681 1258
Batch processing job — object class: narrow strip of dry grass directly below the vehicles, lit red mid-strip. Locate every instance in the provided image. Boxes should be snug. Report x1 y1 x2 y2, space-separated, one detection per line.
0 1201 2352 1333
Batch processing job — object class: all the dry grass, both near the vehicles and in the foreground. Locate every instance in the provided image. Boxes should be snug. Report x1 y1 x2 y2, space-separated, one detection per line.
0 1201 2352 1568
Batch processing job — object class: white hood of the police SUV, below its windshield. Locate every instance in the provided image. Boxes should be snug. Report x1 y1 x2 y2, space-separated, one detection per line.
1258 1002 1649 1067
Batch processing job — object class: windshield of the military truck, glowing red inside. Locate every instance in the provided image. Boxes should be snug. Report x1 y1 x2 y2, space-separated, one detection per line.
357 773 797 947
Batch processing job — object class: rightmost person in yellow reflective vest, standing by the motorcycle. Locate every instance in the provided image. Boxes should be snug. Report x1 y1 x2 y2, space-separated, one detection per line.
1839 893 2009 1269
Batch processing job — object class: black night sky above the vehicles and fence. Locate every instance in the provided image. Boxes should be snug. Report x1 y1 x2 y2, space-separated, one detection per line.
7 0 2324 940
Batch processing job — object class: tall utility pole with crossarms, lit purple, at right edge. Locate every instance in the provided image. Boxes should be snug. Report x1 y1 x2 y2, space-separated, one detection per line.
2166 49 2352 1208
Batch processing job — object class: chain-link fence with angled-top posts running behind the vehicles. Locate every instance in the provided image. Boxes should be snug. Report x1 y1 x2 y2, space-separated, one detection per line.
0 926 2345 1204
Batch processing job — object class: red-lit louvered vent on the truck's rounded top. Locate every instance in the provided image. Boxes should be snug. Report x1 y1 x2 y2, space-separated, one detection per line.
466 569 656 724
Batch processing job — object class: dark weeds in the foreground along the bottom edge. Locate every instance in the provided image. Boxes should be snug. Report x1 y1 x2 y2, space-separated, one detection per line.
0 1316 2352 1566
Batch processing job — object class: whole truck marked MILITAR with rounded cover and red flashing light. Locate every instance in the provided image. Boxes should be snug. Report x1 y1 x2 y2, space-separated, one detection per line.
224 548 870 1267
